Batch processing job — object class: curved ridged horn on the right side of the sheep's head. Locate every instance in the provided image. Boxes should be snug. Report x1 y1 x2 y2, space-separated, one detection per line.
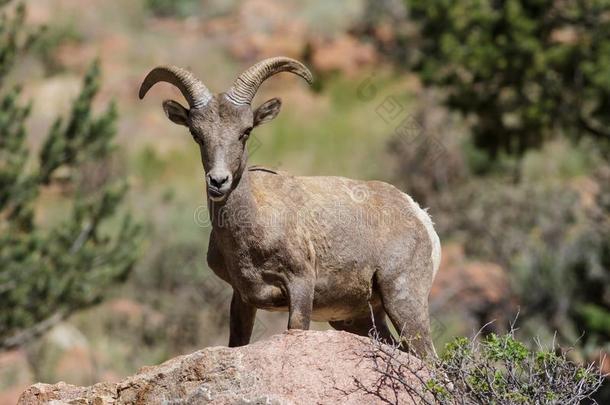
226 56 313 105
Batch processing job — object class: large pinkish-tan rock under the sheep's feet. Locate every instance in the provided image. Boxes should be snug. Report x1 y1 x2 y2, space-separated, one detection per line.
19 331 425 405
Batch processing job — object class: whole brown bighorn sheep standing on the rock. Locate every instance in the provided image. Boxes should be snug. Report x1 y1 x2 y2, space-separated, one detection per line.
139 57 440 353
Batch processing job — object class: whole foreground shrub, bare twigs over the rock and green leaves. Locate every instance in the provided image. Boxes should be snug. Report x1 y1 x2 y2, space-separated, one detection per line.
357 330 603 405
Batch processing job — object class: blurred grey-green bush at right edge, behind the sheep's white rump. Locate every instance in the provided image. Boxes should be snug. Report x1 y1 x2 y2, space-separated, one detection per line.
433 161 610 348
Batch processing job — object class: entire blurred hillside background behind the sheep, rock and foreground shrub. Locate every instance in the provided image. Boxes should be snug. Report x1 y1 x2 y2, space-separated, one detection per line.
0 0 610 404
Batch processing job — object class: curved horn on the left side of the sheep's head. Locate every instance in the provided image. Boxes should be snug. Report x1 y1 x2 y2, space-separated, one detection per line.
139 66 212 108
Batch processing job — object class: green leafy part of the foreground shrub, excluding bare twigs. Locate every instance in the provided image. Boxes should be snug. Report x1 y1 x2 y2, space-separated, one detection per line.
431 332 603 404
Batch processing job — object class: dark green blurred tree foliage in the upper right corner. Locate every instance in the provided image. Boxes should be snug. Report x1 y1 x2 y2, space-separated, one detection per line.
403 0 610 163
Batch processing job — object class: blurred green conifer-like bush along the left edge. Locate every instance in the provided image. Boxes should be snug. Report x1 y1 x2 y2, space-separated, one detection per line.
0 1 139 350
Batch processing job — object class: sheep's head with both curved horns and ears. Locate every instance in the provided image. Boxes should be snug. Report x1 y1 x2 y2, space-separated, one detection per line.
140 56 312 201
